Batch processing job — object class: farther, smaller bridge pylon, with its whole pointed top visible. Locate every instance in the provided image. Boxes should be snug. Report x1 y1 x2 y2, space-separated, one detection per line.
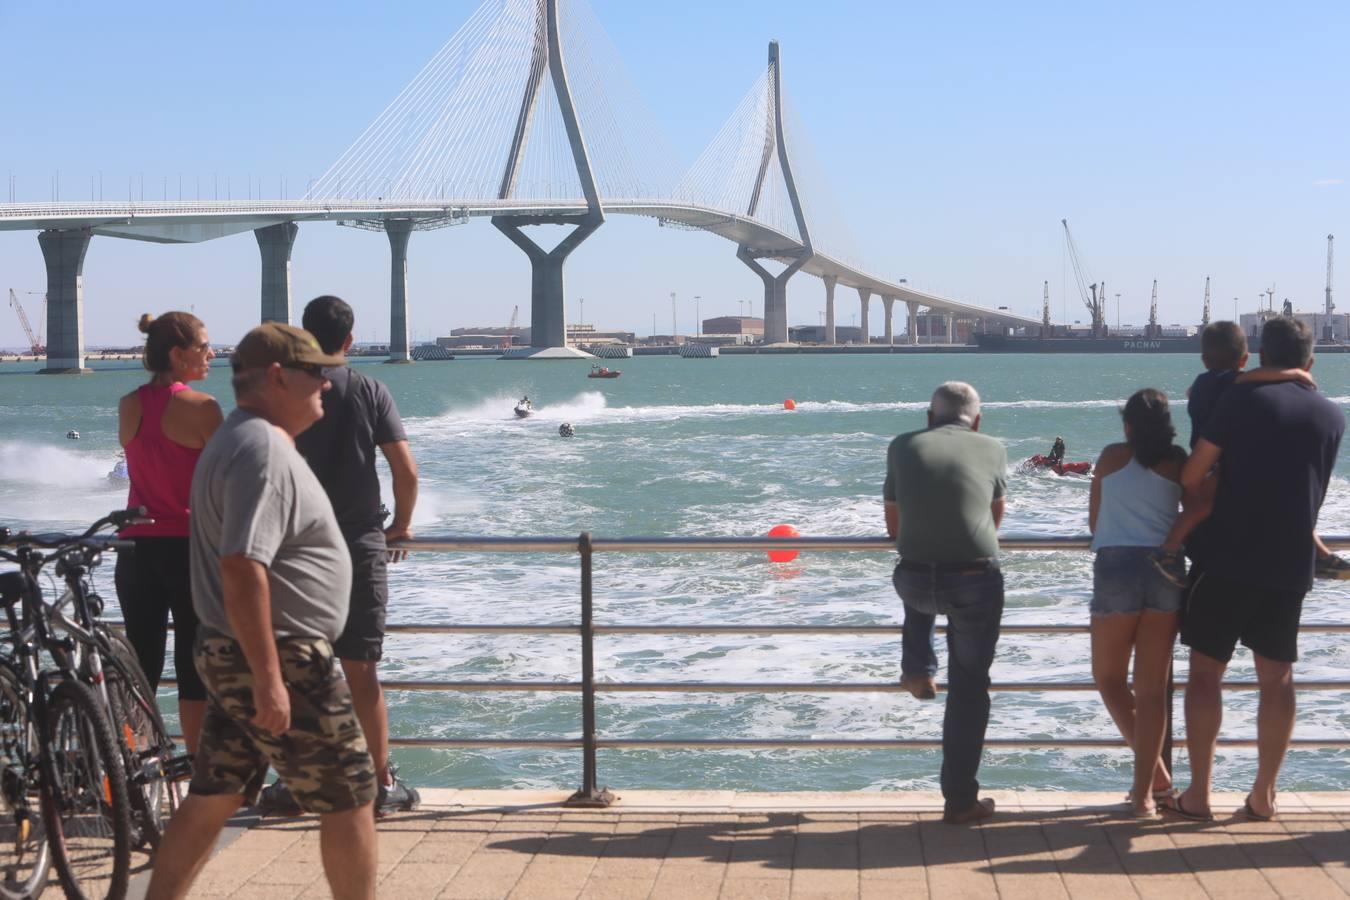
736 40 815 344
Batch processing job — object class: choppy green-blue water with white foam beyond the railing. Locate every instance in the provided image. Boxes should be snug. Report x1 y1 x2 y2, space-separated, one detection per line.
0 355 1350 789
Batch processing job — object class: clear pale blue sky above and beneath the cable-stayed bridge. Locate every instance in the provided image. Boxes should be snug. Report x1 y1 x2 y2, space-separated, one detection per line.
0 0 1350 347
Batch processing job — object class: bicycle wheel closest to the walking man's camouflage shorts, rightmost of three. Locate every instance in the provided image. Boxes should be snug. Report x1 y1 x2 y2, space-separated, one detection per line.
103 630 185 847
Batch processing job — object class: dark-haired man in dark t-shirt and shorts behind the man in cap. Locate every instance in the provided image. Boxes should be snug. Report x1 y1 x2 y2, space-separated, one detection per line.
263 297 420 815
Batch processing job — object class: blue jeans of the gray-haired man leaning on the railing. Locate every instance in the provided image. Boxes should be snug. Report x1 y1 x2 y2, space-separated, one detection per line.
892 563 1003 811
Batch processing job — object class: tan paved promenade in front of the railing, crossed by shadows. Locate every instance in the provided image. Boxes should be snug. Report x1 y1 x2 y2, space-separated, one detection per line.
121 791 1350 900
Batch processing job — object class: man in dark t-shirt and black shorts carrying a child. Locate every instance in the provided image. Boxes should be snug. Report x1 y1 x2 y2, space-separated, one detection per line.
1164 317 1345 820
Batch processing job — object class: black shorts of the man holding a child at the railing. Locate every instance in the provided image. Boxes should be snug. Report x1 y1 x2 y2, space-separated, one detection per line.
1181 567 1307 664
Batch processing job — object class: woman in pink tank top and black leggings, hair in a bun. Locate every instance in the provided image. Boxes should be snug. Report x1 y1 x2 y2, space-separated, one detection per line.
116 313 221 752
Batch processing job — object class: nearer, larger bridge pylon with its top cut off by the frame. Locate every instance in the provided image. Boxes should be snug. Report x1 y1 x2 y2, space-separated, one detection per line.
493 0 605 359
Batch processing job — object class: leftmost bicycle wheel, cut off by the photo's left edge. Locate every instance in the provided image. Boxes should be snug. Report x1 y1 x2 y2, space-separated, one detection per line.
0 664 51 900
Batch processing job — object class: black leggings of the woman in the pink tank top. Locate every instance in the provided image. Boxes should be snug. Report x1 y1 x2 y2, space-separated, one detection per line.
116 537 207 700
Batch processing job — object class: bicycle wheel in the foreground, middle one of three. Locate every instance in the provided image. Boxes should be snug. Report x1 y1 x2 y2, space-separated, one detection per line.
43 681 131 900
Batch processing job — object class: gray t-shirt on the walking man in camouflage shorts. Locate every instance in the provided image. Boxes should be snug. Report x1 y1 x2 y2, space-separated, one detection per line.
190 409 351 641
